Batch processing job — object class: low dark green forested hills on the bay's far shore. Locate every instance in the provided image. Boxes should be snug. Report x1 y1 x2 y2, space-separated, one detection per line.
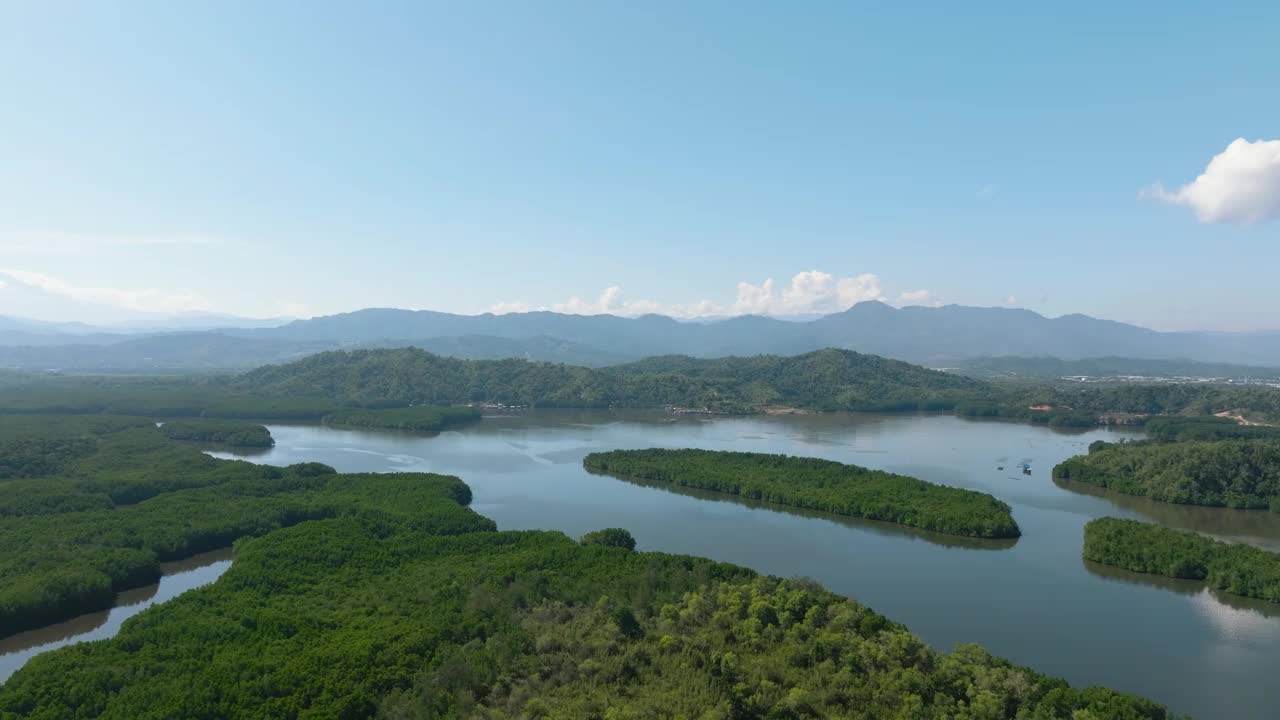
238 348 991 411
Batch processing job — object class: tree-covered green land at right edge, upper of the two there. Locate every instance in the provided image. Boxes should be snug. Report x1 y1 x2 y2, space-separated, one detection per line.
1053 439 1280 512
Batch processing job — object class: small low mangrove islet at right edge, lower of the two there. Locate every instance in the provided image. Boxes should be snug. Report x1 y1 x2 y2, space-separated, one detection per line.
1084 518 1280 602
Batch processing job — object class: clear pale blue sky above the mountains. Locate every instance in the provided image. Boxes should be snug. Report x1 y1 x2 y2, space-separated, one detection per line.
0 0 1280 329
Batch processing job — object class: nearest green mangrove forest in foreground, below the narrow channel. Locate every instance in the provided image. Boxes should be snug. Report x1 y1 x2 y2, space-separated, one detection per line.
0 518 1169 720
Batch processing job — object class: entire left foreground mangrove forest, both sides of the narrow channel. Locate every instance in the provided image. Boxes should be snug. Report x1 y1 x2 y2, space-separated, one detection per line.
0 416 1170 720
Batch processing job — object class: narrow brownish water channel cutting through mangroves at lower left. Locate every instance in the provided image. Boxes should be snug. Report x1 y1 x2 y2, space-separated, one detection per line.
0 547 232 683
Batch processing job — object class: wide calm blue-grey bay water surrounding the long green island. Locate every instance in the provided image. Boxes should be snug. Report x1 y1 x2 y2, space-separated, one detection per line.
202 411 1280 719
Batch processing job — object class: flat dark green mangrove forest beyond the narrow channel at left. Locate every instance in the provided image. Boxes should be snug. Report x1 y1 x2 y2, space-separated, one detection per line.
0 418 492 637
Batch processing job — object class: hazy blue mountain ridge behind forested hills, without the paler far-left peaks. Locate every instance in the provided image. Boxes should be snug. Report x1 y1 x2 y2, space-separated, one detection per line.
238 302 1280 365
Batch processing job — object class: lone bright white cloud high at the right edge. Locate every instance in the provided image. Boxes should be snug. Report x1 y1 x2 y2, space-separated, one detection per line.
1138 137 1280 224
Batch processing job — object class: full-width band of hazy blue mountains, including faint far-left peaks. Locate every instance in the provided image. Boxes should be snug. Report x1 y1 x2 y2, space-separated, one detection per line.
0 302 1280 370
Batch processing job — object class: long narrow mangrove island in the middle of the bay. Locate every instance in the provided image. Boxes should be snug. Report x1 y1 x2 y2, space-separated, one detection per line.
582 448 1021 538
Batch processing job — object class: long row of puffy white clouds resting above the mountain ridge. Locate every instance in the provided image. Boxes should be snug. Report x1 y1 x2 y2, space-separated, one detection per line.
489 270 884 318
